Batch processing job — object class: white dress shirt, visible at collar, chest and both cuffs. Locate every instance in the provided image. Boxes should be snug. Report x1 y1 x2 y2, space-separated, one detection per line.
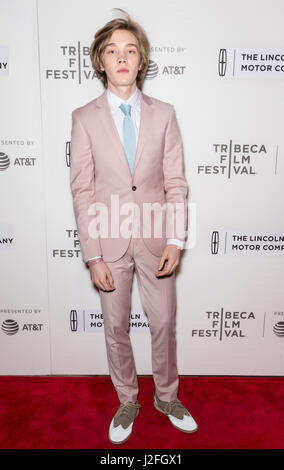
86 86 183 262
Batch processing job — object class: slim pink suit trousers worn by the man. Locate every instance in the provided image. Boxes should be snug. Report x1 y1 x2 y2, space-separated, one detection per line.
99 238 179 403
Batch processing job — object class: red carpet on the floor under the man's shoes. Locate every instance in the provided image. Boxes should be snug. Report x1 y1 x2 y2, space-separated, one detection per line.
0 376 284 449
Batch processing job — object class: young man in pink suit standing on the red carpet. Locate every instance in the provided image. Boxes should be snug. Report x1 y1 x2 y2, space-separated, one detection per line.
70 10 198 444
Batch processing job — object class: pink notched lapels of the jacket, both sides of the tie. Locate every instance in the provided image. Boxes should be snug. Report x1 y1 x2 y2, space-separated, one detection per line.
95 90 152 180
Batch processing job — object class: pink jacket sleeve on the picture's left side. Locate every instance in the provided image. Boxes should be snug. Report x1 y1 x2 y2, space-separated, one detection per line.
70 110 102 262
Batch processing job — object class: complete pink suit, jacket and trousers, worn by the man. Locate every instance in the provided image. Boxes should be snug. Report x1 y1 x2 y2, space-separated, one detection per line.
70 91 188 403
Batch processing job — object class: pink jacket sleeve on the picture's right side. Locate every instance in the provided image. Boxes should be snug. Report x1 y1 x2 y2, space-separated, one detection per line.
163 105 189 242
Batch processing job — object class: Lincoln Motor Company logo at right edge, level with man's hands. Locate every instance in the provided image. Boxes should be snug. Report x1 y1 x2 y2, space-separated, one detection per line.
210 230 284 256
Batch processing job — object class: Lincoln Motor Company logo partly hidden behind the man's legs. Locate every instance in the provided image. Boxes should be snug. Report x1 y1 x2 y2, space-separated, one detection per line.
69 309 149 333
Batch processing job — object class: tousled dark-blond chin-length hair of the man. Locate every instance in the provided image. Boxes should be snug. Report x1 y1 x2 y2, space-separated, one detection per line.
90 8 150 90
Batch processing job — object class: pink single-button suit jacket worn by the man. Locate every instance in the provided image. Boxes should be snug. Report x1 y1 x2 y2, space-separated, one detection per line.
70 90 188 262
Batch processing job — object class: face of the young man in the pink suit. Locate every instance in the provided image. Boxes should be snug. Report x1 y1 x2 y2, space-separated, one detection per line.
101 29 141 86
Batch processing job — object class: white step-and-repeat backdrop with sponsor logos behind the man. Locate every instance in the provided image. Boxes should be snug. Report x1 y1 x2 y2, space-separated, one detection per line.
0 0 284 376
